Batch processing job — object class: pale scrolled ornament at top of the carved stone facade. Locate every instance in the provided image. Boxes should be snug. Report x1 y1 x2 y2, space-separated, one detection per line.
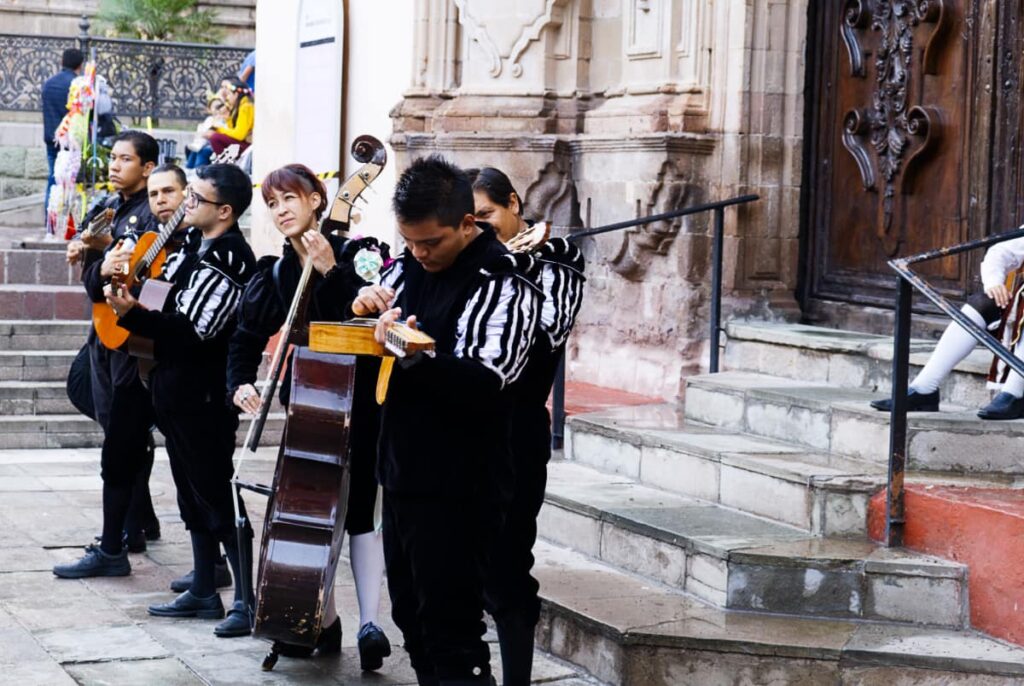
455 0 568 79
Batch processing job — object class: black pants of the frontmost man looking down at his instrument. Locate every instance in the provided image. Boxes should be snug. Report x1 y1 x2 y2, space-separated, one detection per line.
384 489 500 680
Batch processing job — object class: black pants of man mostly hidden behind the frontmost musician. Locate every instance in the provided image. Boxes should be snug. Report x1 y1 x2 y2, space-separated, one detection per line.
484 404 551 626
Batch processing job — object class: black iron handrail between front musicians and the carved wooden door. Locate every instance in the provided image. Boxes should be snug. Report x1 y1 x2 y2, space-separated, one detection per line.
551 196 760 449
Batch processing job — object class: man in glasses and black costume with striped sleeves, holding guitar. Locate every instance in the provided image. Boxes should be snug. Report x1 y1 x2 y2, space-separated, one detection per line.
105 165 256 637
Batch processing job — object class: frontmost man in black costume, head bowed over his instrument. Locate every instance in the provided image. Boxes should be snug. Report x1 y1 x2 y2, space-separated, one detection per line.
353 157 539 686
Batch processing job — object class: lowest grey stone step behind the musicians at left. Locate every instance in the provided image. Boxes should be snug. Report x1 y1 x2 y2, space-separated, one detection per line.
0 413 285 449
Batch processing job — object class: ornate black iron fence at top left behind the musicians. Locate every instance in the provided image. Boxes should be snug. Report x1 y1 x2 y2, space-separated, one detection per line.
0 15 250 120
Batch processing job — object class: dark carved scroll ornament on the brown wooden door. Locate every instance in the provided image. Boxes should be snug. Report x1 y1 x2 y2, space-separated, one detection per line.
840 0 946 255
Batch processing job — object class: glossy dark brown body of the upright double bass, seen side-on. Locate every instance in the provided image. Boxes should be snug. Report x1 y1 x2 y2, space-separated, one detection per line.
253 347 355 648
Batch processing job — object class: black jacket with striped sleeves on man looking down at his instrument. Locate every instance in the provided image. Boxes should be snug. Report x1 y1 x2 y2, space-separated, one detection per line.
378 227 539 499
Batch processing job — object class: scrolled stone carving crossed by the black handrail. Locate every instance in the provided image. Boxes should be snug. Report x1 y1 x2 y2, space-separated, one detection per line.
609 161 697 281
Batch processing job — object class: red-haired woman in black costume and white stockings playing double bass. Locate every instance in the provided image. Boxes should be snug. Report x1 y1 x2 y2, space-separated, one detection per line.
227 164 391 670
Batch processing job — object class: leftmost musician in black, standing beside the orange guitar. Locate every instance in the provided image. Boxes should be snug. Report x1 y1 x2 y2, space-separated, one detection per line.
53 131 165 578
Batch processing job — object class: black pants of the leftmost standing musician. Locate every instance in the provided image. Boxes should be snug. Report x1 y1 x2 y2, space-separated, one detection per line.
89 334 157 533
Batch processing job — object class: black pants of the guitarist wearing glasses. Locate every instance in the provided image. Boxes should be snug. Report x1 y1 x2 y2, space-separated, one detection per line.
155 396 246 542
